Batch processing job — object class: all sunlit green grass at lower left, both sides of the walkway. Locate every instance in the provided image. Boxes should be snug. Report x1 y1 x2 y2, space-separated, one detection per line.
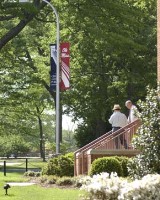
0 159 82 200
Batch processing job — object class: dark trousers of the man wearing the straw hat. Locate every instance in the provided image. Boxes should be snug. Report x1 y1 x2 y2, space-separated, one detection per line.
112 127 128 149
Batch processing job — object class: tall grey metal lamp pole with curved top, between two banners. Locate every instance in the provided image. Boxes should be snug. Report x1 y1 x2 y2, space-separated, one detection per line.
42 0 60 154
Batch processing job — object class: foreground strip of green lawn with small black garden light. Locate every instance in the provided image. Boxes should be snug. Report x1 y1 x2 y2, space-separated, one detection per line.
0 183 81 200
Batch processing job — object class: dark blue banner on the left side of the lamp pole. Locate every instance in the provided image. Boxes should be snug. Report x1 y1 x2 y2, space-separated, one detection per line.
50 44 57 91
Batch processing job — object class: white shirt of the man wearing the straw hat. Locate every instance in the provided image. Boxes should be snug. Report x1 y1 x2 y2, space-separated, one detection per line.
108 111 128 127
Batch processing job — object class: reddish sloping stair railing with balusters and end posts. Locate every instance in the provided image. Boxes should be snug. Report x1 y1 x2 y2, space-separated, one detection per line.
74 119 140 175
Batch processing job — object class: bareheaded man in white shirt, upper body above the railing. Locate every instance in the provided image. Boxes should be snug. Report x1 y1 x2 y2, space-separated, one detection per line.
125 100 138 123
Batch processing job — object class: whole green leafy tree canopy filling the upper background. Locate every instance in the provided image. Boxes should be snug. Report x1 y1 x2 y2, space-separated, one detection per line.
0 0 156 146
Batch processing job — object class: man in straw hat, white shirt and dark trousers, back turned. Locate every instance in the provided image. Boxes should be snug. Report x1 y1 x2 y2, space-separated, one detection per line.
108 104 128 149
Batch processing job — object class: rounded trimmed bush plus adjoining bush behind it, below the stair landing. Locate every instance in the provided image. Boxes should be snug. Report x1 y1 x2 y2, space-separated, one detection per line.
89 156 128 177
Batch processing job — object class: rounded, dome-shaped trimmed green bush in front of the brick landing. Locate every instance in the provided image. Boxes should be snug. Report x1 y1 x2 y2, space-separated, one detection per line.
89 157 123 176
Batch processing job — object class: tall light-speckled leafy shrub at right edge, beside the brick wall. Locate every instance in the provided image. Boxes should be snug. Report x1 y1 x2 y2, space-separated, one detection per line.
128 88 160 178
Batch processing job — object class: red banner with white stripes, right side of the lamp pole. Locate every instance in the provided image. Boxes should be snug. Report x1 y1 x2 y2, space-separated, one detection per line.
60 42 70 91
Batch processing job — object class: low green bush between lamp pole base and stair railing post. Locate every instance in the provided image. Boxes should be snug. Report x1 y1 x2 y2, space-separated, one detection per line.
42 154 74 177
